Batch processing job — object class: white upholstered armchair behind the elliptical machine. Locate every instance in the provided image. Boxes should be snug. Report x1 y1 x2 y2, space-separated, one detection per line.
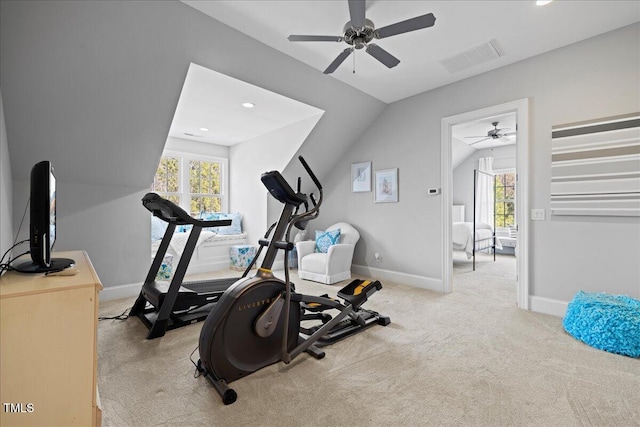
296 222 360 285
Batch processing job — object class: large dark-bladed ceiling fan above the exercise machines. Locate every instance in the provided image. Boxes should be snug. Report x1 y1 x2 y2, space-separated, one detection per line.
287 0 436 74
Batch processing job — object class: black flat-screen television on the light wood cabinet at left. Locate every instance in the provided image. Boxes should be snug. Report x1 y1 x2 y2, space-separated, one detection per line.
14 160 75 273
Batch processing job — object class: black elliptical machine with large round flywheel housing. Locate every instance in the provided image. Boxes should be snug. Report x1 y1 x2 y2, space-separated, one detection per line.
197 156 390 405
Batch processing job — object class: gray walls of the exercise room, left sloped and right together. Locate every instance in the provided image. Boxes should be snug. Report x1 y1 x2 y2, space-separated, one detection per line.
0 1 640 308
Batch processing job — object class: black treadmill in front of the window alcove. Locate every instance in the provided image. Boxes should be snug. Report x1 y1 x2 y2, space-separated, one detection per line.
129 193 245 339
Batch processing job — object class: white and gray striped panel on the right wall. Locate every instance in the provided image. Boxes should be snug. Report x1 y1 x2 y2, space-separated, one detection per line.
551 113 640 216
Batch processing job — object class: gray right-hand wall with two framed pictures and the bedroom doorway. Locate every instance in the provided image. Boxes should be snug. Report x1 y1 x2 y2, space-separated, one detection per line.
320 24 640 301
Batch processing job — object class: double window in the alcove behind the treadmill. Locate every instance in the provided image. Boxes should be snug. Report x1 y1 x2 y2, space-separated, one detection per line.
151 152 228 217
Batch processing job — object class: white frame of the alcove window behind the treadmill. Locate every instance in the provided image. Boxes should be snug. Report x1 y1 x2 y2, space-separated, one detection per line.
152 150 229 214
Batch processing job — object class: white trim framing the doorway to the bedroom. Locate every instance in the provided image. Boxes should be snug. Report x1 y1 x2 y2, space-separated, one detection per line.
441 98 529 310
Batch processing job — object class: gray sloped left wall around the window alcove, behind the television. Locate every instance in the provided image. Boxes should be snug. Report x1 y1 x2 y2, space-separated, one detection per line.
0 0 385 286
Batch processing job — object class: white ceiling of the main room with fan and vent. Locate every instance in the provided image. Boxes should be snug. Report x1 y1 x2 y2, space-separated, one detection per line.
183 0 640 103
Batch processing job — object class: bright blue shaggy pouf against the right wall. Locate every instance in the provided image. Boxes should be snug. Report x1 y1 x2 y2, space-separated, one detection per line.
562 291 640 357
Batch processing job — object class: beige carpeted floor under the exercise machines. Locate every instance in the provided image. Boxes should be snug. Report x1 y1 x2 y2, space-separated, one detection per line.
98 256 640 427
